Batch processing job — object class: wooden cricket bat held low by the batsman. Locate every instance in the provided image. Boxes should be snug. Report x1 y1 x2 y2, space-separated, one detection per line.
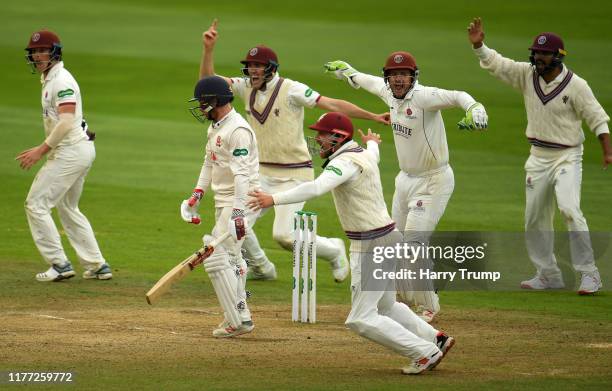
146 232 230 305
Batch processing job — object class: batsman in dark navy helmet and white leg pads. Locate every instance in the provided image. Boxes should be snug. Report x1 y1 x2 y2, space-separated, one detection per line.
181 76 259 338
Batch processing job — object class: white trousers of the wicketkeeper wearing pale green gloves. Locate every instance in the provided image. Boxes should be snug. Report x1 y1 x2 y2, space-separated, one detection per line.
391 165 455 312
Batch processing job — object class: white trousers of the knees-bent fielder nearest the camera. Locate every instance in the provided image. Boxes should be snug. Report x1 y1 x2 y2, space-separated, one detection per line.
346 231 438 361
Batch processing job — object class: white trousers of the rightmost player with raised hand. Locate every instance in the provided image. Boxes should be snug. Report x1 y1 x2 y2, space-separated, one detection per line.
525 146 597 279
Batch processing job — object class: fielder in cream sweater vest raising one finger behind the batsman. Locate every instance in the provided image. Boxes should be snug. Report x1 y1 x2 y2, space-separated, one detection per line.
200 20 388 282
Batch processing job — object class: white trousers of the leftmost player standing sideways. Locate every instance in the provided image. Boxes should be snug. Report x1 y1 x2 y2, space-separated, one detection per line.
25 140 105 270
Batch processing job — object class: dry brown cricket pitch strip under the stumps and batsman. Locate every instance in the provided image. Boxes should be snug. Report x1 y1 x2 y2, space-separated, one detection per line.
0 298 612 389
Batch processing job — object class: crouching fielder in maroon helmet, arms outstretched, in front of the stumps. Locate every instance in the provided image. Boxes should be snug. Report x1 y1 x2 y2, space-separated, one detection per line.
248 112 455 374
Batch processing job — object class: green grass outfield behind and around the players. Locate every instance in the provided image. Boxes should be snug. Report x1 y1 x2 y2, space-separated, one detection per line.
0 0 612 390
